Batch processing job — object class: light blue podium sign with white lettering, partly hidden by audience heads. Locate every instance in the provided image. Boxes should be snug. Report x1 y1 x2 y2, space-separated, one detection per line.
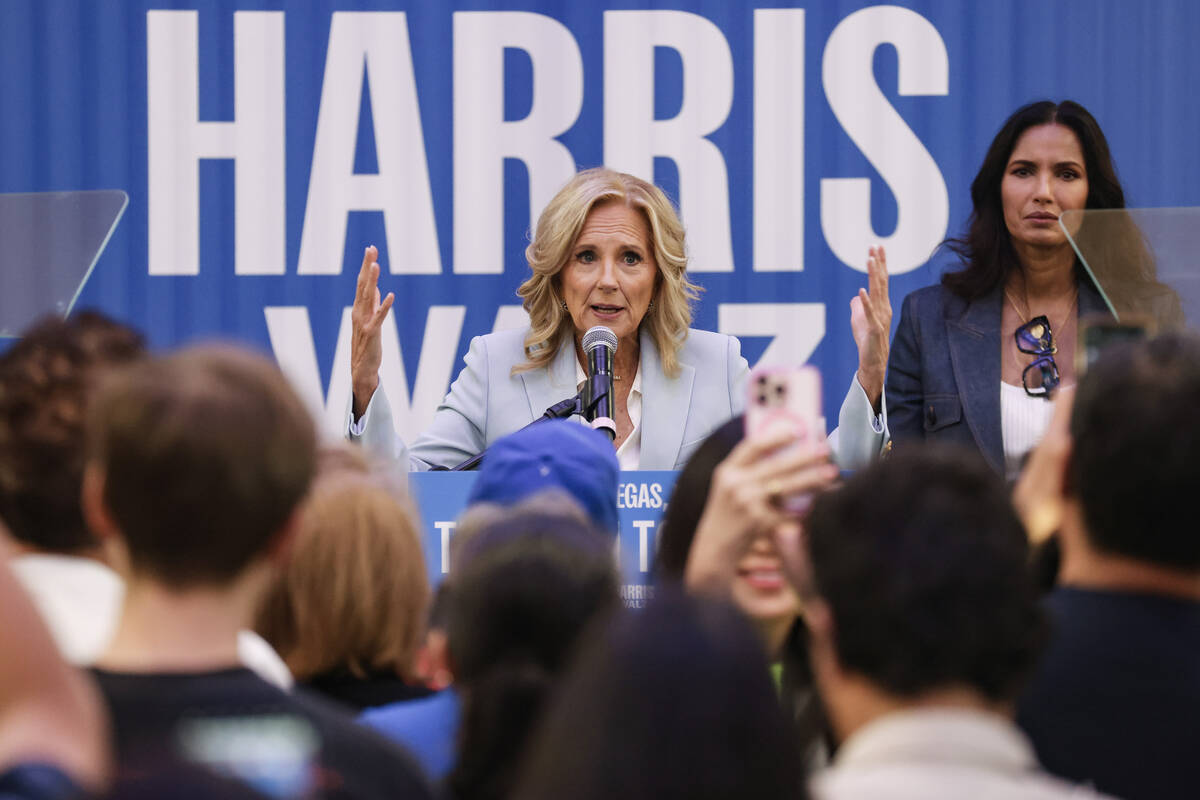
408 470 677 608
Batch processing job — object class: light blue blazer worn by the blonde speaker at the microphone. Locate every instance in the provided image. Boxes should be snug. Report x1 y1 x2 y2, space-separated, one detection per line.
352 329 749 470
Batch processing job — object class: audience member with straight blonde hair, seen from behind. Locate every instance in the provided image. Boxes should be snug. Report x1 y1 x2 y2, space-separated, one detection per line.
256 467 430 711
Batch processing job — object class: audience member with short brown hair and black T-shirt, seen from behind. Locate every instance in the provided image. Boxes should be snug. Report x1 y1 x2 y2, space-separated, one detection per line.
83 348 430 799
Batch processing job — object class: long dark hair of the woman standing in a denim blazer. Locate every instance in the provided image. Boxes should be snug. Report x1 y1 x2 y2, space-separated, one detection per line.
942 100 1124 300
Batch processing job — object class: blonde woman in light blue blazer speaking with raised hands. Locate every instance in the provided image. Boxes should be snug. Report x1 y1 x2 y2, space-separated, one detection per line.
348 167 866 470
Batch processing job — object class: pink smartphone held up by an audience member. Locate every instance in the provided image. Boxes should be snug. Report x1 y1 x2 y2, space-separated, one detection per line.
745 367 824 443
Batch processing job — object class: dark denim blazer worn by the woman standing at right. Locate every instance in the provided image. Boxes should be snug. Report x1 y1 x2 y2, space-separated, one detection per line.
886 279 1108 475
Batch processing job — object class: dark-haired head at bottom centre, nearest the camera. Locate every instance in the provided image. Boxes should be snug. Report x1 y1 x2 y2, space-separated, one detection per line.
512 589 804 800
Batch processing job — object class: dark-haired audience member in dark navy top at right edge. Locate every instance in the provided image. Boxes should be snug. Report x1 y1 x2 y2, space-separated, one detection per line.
1018 333 1200 800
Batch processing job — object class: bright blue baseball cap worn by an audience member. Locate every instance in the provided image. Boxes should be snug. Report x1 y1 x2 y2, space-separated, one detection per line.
467 420 620 534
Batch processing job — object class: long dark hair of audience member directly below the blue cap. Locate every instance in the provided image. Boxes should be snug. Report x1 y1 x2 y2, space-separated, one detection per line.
448 507 618 800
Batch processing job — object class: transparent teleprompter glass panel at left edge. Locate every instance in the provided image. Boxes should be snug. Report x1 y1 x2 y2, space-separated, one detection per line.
0 190 130 337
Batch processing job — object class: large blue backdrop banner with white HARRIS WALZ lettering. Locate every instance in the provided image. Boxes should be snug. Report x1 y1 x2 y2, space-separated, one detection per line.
0 0 1200 440
